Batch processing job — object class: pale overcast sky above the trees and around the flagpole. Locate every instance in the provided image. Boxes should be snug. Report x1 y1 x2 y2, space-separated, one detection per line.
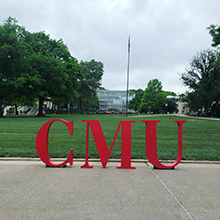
0 0 220 94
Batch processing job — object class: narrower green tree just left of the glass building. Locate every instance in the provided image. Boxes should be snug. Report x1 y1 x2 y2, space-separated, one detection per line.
77 59 104 114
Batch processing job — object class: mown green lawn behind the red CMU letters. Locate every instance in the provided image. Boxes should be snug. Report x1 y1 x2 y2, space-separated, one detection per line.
0 115 220 160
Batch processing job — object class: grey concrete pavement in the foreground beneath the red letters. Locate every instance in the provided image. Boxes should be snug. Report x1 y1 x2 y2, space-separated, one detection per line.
0 158 220 220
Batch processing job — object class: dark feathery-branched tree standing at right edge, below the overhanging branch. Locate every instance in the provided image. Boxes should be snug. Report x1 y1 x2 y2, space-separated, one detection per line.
180 50 220 115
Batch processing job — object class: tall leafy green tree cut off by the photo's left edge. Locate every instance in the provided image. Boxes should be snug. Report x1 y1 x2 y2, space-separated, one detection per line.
0 17 30 117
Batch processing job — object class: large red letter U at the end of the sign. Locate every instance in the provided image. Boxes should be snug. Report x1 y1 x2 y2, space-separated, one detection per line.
141 120 187 169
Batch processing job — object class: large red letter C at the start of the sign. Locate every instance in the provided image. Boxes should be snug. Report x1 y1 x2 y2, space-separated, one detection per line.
36 119 73 167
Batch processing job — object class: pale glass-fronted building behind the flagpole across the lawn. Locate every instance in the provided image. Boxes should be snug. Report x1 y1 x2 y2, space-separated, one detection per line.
97 90 135 111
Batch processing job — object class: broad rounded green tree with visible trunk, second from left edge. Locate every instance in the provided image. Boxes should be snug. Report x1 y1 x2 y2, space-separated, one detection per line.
27 32 82 116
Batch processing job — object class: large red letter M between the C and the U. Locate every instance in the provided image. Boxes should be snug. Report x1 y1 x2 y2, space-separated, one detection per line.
81 120 135 169
